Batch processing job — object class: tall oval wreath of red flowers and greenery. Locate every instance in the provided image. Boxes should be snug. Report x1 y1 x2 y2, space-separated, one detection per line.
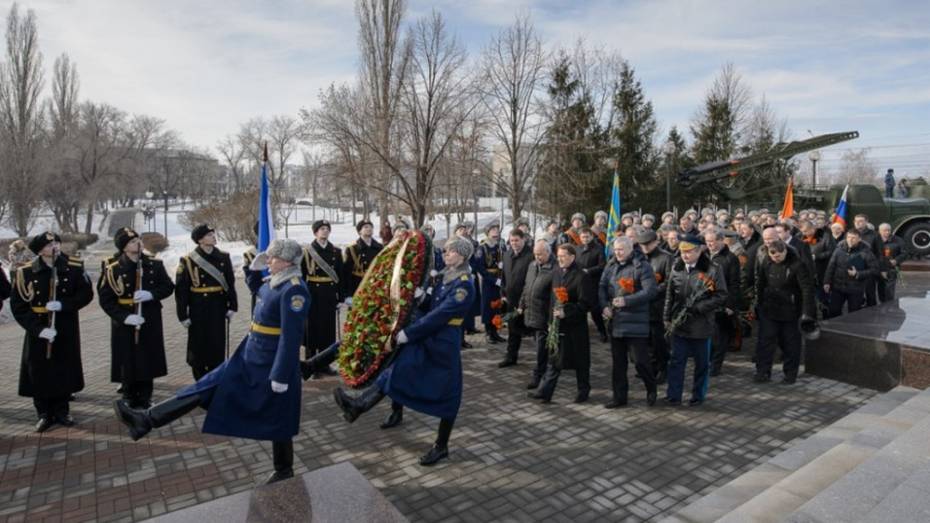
337 230 433 389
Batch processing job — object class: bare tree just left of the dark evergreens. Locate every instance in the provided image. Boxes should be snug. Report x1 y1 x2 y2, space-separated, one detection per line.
478 11 546 218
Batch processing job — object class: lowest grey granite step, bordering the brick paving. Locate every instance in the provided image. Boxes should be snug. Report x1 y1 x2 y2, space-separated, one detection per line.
664 386 920 523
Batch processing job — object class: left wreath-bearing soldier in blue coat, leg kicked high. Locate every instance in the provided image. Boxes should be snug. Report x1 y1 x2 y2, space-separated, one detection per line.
114 240 310 483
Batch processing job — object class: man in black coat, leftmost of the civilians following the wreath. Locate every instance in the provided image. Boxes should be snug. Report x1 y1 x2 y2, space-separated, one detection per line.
497 229 533 368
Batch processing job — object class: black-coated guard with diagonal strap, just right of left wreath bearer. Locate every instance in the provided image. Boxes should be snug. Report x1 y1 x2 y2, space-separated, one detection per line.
301 220 343 372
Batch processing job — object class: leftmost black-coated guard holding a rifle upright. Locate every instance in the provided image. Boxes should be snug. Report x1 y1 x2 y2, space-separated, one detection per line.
9 233 94 432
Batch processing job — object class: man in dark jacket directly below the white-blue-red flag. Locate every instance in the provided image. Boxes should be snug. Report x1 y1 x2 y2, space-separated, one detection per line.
823 229 878 318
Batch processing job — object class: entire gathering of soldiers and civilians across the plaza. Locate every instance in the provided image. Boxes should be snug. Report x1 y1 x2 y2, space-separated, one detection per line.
0 205 907 474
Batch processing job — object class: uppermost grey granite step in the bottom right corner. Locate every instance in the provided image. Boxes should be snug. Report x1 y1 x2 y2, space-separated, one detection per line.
788 389 930 523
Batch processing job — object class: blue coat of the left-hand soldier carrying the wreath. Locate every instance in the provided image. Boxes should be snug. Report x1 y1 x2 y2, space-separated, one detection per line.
177 271 310 441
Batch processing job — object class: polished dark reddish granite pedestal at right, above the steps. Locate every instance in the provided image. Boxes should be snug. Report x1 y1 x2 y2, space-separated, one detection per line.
804 272 930 391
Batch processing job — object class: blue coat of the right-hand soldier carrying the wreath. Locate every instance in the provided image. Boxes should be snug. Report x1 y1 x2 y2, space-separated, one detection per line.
377 273 475 419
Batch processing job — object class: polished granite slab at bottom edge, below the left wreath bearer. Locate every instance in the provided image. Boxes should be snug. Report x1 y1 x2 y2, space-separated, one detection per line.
149 462 407 523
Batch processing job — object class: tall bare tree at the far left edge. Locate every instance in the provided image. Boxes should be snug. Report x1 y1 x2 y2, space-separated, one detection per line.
0 3 44 236
